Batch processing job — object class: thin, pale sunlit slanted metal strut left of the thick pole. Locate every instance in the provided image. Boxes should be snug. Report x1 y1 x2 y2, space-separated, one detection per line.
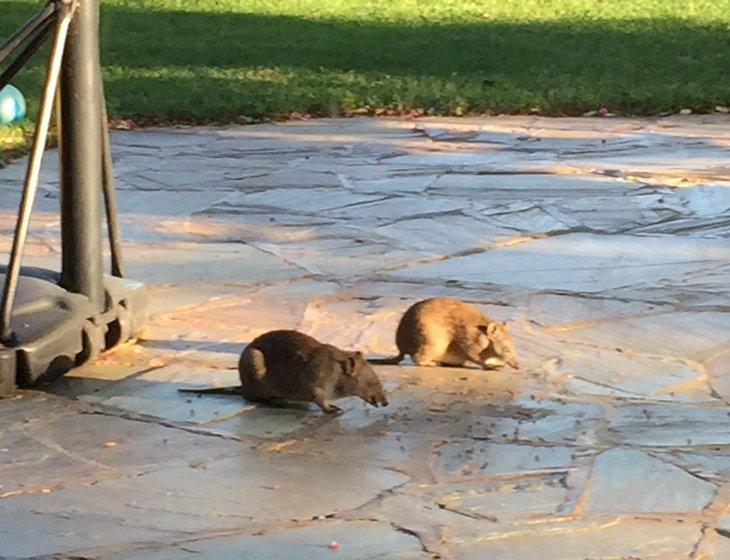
0 6 72 340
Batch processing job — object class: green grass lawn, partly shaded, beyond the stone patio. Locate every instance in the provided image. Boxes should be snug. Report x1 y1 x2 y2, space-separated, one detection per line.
0 0 730 127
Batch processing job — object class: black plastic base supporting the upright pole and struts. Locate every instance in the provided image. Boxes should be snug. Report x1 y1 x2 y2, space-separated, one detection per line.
0 265 147 396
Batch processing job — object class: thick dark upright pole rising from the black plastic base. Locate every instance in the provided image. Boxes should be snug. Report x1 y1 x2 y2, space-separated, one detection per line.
59 0 105 312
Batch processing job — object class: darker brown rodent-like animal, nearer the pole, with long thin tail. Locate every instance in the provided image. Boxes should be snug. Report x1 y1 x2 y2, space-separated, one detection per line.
182 330 388 414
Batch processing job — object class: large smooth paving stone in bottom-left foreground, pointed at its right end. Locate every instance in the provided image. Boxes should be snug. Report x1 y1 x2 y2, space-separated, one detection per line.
0 444 406 557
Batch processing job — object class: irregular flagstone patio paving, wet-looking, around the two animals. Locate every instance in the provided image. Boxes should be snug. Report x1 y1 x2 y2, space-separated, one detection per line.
0 116 730 560
